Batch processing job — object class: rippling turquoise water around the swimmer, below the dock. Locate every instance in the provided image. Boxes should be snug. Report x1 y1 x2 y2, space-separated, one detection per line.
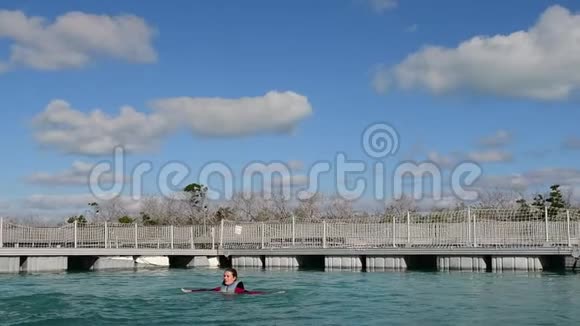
0 269 580 325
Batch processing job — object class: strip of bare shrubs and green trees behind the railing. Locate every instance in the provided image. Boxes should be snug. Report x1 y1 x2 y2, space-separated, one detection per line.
3 183 580 226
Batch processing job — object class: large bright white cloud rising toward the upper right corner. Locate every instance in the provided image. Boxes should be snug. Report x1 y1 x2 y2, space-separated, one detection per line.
373 5 580 100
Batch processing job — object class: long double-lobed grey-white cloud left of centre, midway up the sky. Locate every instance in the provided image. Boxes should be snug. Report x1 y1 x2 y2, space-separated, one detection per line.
33 91 312 155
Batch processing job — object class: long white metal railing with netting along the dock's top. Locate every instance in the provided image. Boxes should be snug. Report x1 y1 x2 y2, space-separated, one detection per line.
0 209 580 249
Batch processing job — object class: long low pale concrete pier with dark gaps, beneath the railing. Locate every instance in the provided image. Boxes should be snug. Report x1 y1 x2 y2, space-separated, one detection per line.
0 247 580 273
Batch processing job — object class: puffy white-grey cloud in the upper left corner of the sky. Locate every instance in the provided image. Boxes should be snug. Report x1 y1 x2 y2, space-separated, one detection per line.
0 10 157 71
